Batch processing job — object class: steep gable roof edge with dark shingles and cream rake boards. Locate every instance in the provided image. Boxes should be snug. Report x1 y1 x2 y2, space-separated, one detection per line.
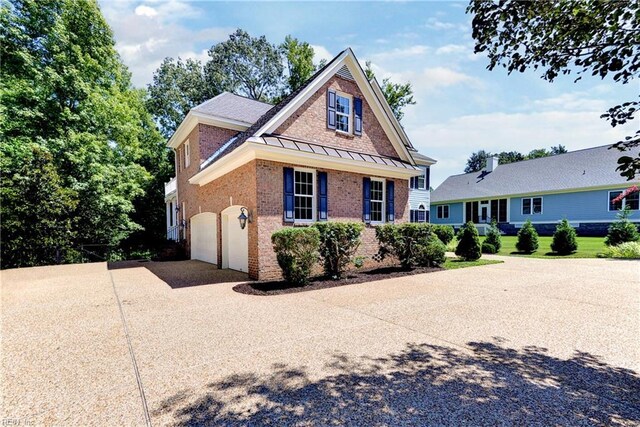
202 48 414 172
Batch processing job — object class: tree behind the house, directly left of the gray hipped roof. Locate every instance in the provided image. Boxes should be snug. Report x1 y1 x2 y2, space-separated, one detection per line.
147 58 212 138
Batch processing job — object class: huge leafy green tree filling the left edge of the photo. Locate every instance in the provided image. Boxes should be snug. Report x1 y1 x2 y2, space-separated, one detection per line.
0 0 161 266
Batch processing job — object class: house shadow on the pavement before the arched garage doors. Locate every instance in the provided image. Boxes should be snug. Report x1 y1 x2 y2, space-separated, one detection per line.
107 260 249 289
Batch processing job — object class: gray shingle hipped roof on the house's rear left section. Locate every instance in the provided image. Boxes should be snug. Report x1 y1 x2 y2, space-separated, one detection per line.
191 92 273 125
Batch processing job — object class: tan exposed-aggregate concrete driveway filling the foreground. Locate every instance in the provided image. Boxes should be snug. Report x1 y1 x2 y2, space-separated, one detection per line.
0 258 640 426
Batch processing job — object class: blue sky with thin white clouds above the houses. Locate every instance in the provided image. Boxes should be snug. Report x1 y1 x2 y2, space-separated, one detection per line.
100 0 639 187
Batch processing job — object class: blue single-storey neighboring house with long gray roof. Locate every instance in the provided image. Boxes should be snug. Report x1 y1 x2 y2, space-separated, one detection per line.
431 145 640 236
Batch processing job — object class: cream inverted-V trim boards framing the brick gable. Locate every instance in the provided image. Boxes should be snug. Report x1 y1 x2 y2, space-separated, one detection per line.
253 49 415 165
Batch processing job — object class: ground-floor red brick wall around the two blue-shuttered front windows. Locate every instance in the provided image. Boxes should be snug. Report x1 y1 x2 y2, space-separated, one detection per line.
256 160 409 280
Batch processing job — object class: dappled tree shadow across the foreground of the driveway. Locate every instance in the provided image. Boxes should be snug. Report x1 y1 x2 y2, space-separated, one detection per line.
152 339 640 426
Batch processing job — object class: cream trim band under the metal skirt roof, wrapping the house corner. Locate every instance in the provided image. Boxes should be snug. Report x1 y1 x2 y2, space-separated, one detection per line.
189 140 420 186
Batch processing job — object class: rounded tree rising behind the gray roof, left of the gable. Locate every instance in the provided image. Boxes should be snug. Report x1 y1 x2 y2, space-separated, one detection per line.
205 29 284 101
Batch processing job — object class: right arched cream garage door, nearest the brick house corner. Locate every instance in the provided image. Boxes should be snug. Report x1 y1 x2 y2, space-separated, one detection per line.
222 206 249 273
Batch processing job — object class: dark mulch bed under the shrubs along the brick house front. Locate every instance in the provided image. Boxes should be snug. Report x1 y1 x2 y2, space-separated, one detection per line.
233 267 444 296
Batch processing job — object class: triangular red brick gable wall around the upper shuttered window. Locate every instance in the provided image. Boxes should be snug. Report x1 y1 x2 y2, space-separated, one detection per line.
275 76 400 158
